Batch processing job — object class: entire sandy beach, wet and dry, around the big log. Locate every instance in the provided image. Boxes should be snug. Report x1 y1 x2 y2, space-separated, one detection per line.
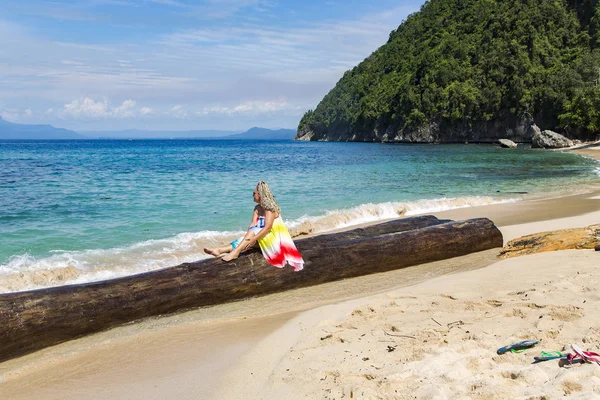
0 146 600 400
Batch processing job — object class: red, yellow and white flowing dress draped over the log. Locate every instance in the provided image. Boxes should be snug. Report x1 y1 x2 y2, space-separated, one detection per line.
258 216 304 271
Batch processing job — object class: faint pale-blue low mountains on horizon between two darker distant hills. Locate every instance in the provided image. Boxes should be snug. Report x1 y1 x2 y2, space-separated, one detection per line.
81 129 240 139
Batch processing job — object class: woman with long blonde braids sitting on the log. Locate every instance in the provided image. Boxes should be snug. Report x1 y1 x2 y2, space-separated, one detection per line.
204 181 304 271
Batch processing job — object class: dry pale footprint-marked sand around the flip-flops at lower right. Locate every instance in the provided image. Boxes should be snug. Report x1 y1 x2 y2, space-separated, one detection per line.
216 250 600 399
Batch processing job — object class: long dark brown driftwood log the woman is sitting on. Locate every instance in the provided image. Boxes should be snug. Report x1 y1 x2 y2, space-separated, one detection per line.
0 216 502 361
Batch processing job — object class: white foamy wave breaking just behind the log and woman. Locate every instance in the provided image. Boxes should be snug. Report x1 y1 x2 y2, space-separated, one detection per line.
0 196 516 293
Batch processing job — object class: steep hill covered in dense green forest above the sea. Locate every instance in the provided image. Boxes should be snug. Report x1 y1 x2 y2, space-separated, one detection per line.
297 0 600 142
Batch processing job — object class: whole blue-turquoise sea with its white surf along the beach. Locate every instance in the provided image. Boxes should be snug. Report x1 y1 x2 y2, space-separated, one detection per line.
0 140 600 292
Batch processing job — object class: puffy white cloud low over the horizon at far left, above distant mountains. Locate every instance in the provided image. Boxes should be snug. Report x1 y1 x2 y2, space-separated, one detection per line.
58 97 152 119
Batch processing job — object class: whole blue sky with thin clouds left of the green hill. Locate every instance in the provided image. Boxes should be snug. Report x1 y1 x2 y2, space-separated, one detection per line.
0 0 423 131
